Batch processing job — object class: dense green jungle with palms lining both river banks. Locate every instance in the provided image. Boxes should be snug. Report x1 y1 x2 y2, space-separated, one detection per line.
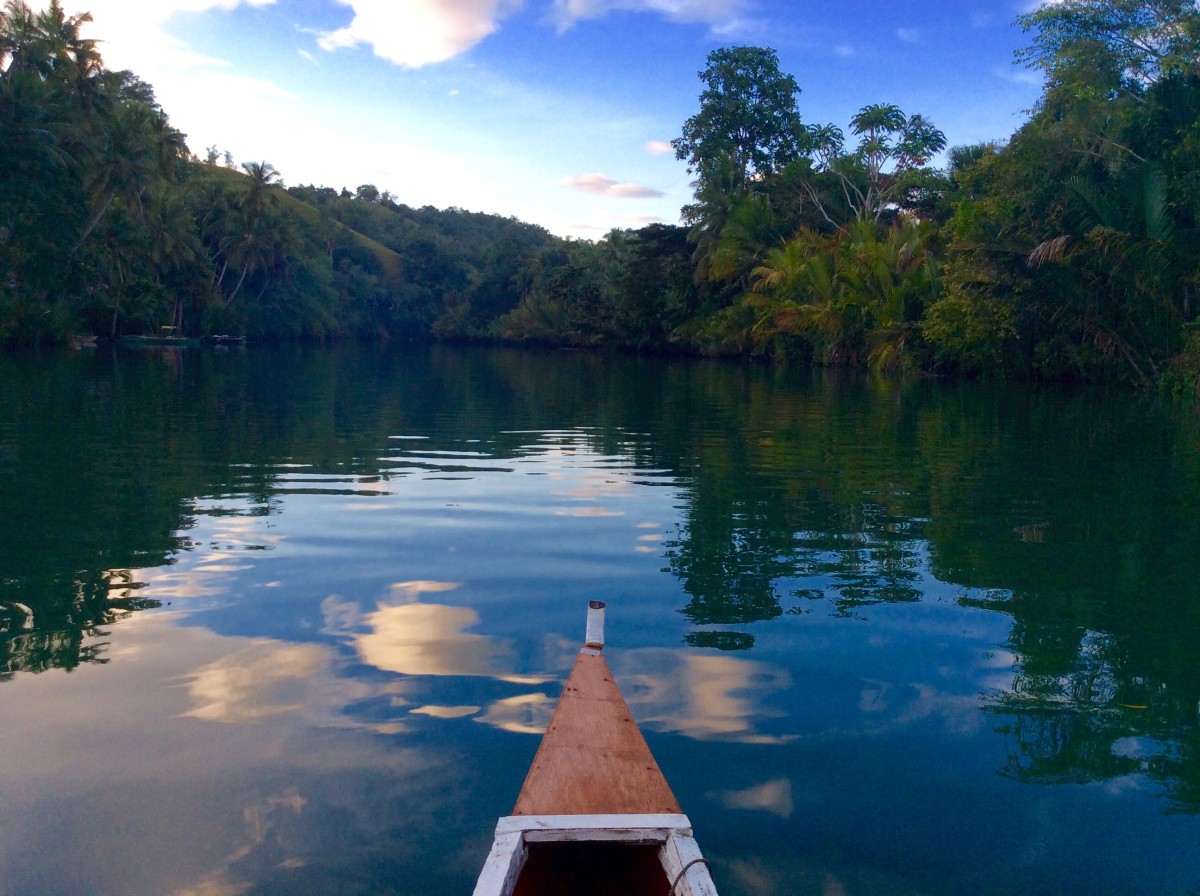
0 0 1200 392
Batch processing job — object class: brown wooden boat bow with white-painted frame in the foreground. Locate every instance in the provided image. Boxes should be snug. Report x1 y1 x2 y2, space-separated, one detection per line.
475 601 716 896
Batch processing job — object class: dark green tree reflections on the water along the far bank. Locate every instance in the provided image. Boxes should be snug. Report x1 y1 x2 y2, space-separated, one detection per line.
0 348 1200 811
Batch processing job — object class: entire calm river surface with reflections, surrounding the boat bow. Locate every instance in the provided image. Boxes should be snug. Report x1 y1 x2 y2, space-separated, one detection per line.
0 348 1200 896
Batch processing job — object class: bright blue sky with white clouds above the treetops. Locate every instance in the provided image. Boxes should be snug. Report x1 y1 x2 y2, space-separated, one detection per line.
64 0 1040 239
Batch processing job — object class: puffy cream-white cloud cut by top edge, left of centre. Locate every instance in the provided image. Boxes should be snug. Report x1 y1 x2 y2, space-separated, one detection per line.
318 0 522 68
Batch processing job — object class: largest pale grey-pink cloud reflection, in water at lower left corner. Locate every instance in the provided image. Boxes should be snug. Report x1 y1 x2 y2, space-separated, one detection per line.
0 613 451 896
